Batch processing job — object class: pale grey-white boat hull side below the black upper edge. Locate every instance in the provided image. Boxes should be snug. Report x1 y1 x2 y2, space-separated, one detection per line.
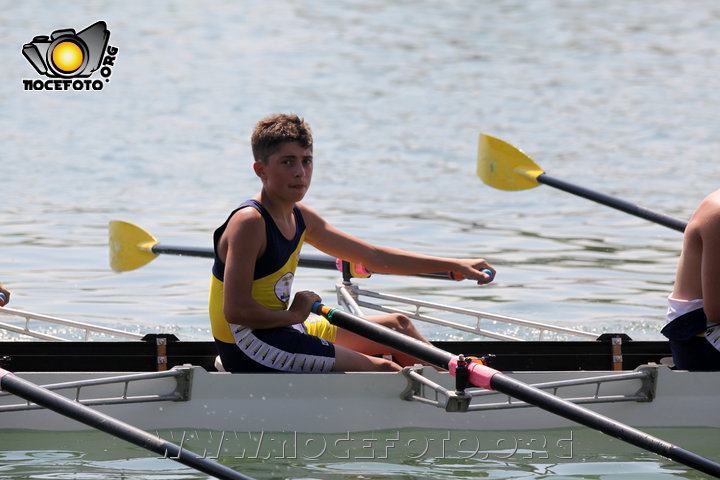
0 367 720 433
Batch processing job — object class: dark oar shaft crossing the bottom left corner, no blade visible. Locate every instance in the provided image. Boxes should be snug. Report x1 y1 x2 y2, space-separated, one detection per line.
0 368 252 480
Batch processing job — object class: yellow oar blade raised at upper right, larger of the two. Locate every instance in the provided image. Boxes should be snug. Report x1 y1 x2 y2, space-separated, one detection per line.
477 133 544 190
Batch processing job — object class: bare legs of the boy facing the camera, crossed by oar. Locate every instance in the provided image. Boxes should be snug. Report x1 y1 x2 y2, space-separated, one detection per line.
334 313 430 367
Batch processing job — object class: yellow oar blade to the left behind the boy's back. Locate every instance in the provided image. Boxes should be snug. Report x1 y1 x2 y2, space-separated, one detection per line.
109 220 159 272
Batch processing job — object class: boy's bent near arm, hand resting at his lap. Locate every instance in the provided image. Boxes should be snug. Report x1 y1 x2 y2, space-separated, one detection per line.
218 208 320 329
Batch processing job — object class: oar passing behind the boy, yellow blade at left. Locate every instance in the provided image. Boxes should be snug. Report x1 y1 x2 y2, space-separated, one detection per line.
109 220 492 282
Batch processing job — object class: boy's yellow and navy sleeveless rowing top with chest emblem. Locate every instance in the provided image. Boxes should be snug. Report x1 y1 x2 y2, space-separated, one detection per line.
209 199 305 343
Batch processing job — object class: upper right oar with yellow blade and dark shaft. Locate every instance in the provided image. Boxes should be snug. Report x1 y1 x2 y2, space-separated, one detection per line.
477 133 687 232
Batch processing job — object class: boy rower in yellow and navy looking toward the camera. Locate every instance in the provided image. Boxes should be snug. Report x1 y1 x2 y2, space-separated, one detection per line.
209 114 495 372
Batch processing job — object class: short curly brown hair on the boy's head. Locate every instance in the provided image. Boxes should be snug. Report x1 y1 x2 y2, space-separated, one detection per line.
250 113 312 163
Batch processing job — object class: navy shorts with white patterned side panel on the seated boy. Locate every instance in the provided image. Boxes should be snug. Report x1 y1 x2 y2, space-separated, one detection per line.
215 325 335 373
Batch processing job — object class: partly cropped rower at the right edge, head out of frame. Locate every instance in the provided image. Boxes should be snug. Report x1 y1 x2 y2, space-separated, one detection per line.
662 190 720 370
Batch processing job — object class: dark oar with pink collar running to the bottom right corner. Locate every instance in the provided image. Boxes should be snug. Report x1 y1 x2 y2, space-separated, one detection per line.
312 303 720 478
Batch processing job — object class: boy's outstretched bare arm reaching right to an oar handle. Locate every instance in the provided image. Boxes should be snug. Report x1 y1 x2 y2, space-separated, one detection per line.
298 205 495 283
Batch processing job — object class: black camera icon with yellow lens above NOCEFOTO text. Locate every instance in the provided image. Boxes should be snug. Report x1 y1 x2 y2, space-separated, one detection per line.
22 22 110 78
